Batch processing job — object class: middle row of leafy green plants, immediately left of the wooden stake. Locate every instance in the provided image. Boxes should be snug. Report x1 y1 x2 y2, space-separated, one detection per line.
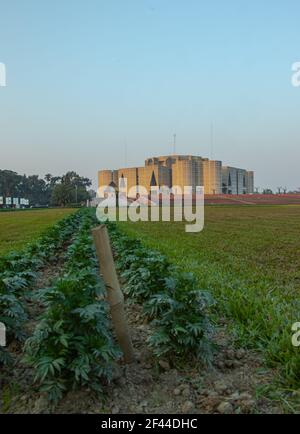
25 212 120 401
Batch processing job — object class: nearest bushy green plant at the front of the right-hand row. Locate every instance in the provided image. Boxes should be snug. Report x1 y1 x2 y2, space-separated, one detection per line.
144 272 214 363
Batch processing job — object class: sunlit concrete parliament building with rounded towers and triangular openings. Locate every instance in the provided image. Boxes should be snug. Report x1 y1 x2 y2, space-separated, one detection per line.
98 155 254 194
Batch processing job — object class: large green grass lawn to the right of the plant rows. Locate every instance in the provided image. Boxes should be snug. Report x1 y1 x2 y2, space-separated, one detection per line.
120 205 300 390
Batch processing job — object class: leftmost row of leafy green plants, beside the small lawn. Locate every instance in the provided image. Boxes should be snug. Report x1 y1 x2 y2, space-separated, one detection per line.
0 213 81 364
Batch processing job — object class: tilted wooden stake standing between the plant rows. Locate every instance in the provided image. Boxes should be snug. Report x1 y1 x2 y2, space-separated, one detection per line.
92 225 134 363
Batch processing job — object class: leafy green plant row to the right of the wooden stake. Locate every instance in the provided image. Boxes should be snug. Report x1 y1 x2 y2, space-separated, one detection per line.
108 223 214 363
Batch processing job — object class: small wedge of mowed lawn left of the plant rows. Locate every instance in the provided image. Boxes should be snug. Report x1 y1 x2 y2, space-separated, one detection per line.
0 209 74 255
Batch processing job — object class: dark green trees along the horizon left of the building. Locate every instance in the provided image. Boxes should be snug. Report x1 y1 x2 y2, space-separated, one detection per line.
0 169 94 206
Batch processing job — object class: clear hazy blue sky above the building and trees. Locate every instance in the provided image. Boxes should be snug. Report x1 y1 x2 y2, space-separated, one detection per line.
0 0 300 188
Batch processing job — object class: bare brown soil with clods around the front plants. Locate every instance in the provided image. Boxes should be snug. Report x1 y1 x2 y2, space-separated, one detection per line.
2 298 281 414
